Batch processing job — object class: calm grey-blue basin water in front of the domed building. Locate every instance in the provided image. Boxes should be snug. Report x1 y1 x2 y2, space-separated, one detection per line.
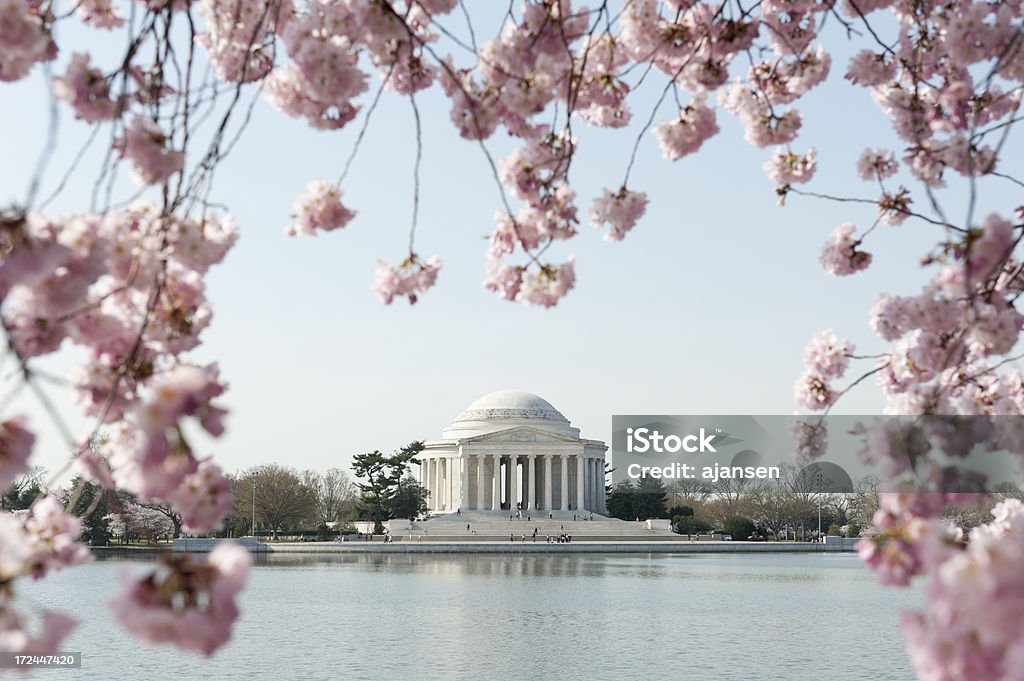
18 554 921 681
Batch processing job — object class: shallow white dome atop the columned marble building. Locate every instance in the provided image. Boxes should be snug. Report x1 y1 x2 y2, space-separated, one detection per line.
443 390 580 438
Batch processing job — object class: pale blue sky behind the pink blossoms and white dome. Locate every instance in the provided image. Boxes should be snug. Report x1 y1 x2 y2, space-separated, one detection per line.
0 3 1013 483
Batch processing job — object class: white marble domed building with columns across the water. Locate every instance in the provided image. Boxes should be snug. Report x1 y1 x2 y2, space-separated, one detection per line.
418 390 608 513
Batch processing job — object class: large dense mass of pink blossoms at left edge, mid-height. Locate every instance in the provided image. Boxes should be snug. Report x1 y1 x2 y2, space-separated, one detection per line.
0 200 238 531
